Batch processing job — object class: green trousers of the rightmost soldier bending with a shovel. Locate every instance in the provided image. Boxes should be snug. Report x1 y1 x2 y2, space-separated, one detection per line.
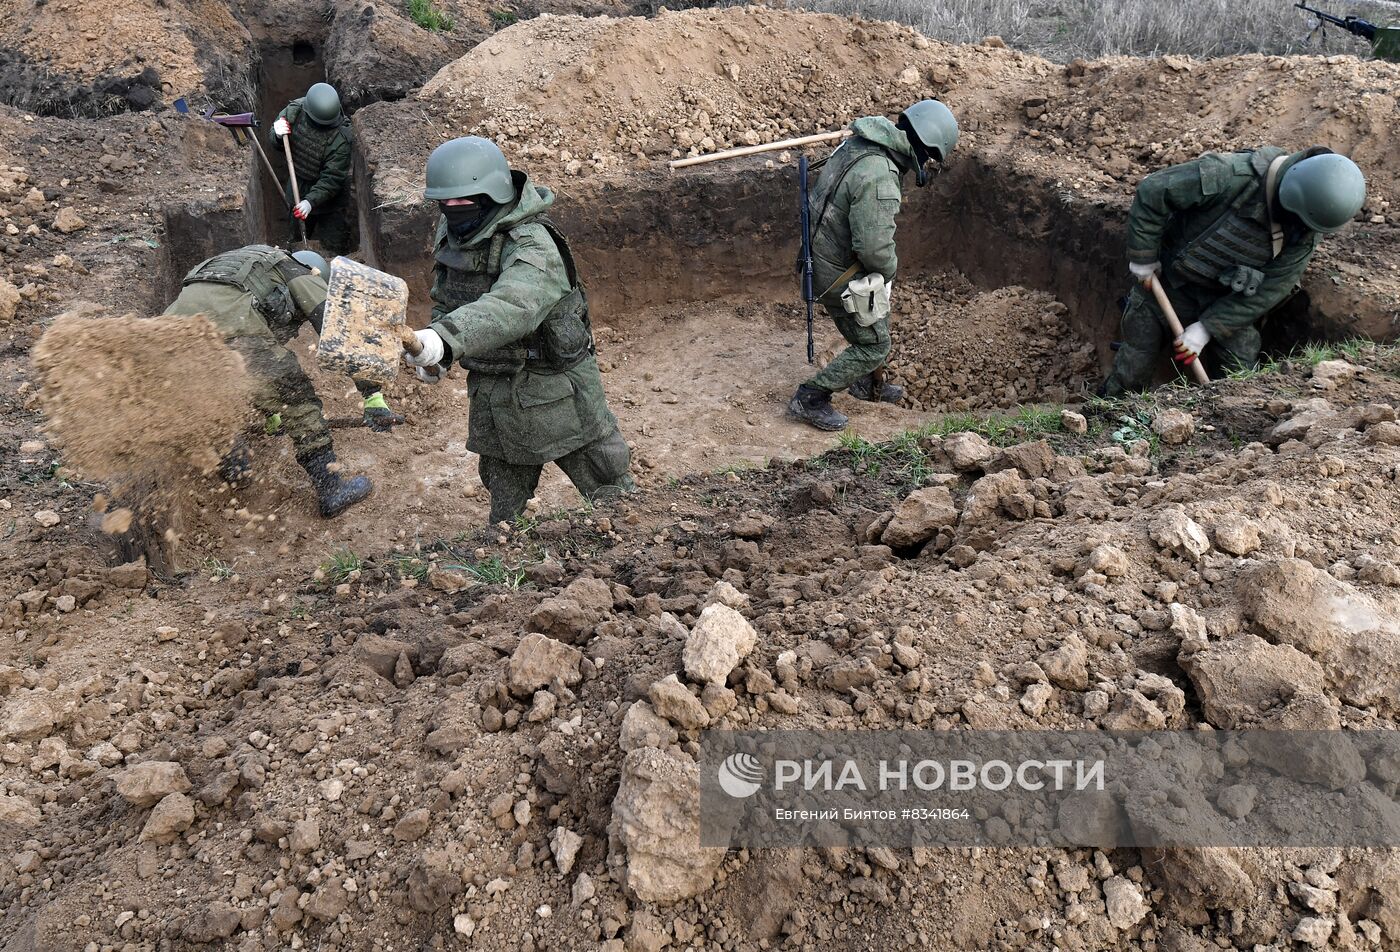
1103 286 1263 396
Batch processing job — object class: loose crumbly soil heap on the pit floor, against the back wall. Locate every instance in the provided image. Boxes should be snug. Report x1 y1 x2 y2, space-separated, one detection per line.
890 273 1098 410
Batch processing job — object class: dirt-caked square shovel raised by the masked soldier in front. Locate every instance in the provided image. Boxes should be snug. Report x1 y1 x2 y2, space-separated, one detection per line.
316 256 423 386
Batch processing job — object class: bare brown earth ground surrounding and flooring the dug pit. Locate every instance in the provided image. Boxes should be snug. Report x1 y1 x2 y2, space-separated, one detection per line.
0 1 1400 952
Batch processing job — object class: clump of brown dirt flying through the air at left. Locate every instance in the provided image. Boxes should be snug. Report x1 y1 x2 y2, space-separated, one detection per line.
34 314 248 491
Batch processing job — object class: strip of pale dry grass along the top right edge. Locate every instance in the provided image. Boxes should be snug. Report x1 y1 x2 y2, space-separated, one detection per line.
688 0 1400 62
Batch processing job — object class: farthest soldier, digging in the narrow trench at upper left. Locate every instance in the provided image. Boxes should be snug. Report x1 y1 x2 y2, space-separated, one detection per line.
269 83 350 255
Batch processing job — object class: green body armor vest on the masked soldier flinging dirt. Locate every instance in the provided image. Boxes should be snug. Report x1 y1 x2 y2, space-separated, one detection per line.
433 216 594 375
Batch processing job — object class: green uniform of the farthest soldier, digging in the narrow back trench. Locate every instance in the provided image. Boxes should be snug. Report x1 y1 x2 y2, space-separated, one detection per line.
269 98 353 258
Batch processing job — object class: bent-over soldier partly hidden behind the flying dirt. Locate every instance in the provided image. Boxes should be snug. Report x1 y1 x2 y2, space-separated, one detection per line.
164 245 383 518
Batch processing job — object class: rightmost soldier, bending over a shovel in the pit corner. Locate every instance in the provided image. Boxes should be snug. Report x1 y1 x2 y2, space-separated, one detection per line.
1099 146 1366 396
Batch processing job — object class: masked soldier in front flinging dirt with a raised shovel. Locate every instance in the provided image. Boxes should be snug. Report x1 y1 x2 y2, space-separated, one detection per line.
405 136 633 524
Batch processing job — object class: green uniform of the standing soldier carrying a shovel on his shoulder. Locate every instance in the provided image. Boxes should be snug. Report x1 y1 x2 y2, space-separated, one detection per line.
806 116 917 392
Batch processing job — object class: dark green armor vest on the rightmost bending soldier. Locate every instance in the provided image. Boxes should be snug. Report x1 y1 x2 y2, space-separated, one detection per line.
1172 148 1287 297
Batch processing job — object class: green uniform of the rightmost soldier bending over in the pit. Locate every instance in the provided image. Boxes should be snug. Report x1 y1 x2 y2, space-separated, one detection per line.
1103 146 1329 396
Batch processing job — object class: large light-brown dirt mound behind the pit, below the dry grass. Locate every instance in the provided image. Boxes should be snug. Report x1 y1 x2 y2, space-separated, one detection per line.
421 7 1053 171
